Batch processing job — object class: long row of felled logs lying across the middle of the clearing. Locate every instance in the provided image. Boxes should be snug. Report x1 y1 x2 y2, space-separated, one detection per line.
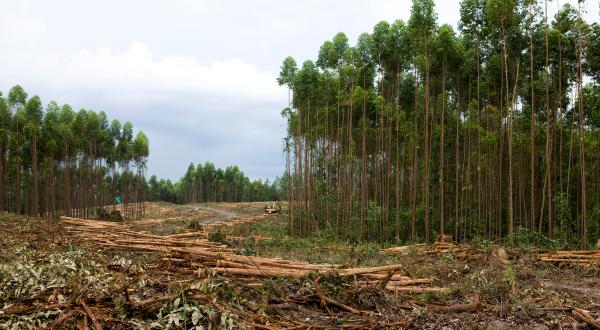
61 217 448 293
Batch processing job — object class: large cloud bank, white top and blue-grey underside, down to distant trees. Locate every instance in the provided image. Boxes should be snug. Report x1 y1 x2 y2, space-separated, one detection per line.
0 42 287 180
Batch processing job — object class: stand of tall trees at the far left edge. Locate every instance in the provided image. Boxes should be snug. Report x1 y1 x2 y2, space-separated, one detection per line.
0 85 148 218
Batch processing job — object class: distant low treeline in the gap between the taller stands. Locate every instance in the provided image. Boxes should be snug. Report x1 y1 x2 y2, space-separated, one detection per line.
148 162 287 204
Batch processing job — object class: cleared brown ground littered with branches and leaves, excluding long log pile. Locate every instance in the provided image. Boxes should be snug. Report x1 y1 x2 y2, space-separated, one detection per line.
0 203 600 329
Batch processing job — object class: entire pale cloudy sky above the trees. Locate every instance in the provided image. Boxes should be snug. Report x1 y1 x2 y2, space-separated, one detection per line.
0 0 600 180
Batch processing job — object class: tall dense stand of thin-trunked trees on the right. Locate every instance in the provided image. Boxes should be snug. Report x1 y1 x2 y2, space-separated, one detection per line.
278 0 600 248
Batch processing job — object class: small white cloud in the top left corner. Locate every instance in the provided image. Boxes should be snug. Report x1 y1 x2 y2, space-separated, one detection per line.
0 1 45 44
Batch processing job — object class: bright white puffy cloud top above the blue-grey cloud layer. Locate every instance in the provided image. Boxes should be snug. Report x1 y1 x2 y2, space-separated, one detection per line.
53 42 285 102
